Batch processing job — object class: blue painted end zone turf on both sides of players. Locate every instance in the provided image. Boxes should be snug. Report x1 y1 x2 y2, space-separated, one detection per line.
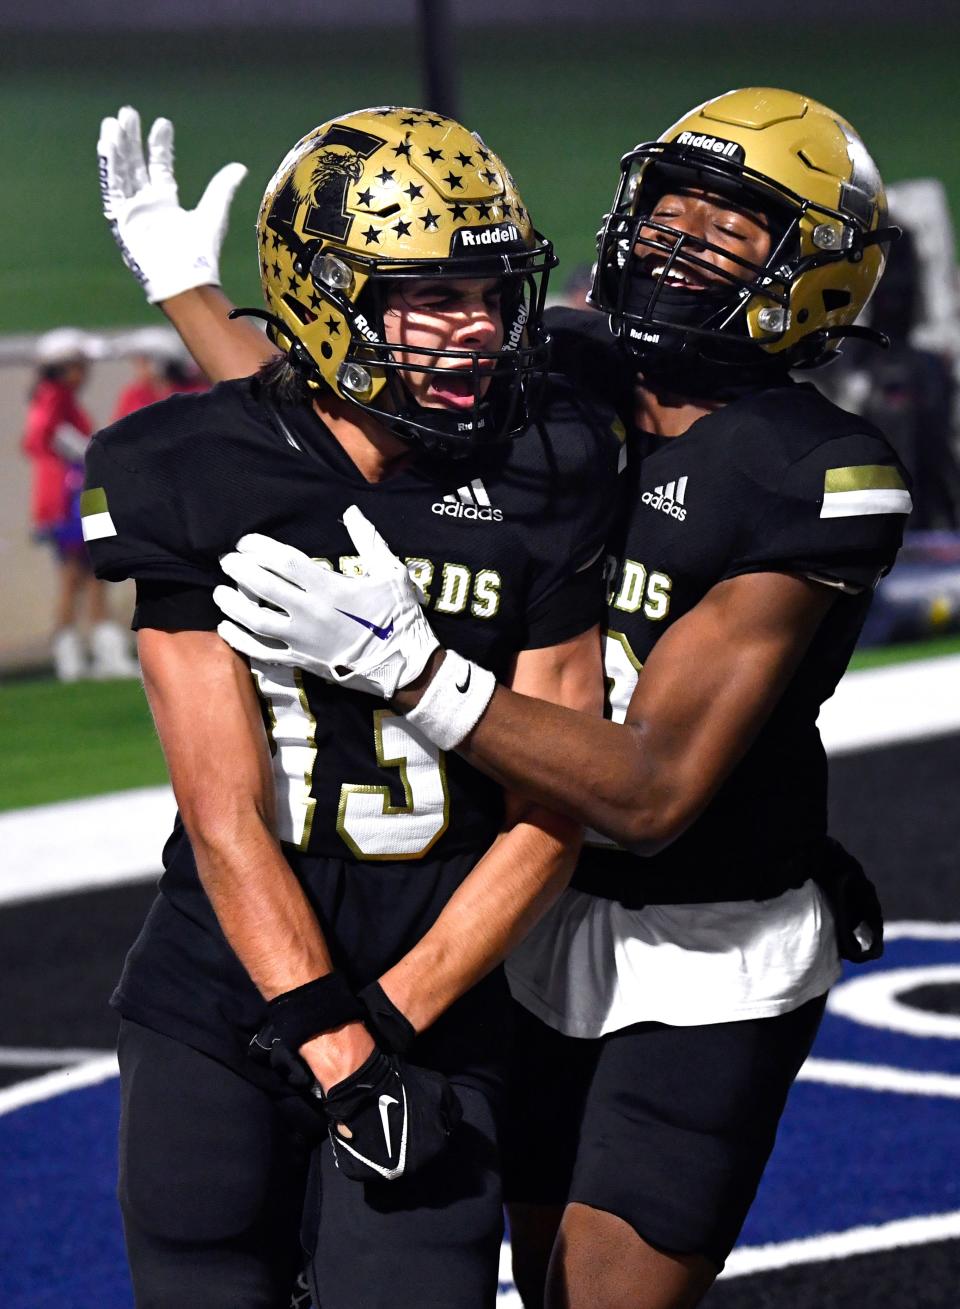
0 940 960 1309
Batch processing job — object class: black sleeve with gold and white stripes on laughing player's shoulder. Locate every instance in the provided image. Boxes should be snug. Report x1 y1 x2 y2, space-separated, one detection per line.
724 433 912 590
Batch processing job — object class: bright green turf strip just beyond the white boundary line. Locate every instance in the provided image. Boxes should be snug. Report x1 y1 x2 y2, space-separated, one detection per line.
0 636 960 809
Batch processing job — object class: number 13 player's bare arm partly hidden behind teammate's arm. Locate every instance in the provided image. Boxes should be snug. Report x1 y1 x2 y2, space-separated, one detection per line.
381 630 602 1030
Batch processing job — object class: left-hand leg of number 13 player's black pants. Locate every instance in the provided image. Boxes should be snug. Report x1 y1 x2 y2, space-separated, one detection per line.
119 1020 310 1309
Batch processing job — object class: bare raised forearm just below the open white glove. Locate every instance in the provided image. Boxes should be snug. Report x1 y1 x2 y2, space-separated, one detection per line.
160 287 279 382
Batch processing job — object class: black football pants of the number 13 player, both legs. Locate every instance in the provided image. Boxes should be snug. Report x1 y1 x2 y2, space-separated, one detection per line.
119 1020 502 1309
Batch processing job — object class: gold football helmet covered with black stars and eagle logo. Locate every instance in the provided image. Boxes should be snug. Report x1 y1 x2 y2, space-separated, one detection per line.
257 107 557 454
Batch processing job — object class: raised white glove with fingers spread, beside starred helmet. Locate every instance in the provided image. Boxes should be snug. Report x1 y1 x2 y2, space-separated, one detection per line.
97 105 246 305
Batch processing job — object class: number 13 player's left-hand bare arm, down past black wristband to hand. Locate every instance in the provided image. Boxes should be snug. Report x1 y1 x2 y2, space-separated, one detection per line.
139 628 372 1084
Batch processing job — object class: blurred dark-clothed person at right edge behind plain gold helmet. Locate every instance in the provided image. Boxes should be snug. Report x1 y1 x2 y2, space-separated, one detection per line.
825 230 960 531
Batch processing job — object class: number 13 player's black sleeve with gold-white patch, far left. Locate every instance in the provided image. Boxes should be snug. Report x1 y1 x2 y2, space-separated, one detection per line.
80 424 217 588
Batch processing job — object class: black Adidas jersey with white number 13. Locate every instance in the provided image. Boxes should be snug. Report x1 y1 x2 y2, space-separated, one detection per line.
84 380 623 861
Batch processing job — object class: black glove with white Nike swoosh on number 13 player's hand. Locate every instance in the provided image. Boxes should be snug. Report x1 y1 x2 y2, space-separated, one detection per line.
313 1050 462 1182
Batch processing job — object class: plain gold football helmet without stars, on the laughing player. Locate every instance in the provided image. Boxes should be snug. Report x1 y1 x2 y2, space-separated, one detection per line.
591 88 898 376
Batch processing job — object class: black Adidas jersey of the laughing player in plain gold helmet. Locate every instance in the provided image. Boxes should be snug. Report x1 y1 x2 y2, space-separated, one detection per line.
575 371 910 905
